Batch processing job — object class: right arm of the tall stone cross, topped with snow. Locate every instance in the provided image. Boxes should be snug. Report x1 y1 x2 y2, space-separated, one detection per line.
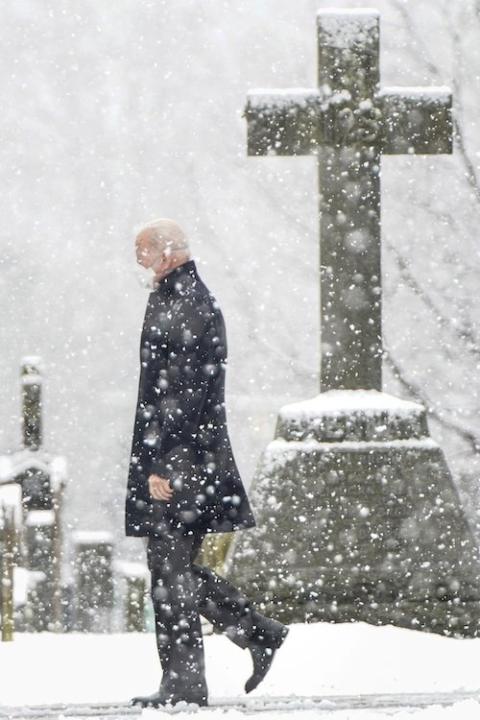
374 86 452 155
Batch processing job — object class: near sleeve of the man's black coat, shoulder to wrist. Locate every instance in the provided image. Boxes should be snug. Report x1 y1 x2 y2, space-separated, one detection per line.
150 303 225 477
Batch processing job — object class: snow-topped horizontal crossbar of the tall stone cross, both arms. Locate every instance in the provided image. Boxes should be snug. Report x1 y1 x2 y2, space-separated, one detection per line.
243 86 452 155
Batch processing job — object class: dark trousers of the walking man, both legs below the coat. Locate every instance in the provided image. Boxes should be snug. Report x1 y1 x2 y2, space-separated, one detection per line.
147 525 285 700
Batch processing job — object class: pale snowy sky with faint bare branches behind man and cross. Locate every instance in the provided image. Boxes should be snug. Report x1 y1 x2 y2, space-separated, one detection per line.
0 0 480 558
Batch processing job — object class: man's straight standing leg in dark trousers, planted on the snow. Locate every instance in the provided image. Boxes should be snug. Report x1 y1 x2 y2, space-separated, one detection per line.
147 527 208 702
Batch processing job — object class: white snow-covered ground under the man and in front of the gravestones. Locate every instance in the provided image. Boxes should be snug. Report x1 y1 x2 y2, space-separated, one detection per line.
0 623 480 720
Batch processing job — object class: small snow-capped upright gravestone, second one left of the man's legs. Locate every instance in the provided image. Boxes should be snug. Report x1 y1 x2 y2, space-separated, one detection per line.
72 530 113 632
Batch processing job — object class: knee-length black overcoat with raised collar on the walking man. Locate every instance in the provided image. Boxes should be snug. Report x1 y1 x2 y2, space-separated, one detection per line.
125 260 256 536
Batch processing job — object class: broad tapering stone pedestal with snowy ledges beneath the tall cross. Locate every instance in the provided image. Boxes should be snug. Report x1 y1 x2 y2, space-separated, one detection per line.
225 390 480 636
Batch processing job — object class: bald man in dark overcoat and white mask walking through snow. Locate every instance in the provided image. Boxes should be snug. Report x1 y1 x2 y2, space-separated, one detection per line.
125 219 289 707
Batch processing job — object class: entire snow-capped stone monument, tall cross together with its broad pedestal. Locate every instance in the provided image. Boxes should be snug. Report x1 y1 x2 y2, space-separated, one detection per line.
225 8 480 636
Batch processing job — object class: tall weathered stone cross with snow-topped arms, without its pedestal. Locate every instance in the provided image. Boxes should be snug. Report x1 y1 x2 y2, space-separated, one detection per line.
245 8 452 391
